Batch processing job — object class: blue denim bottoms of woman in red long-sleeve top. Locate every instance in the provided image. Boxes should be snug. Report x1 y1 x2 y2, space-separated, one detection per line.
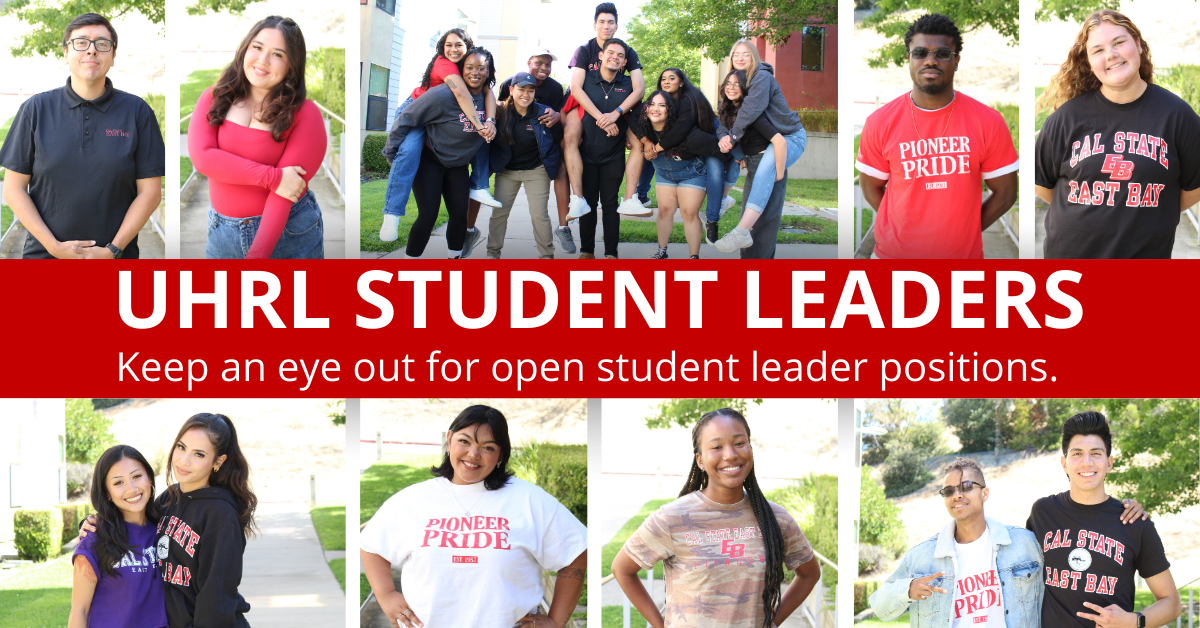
204 190 325 259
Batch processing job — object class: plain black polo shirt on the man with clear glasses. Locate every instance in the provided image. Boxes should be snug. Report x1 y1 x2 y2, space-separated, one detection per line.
0 78 167 259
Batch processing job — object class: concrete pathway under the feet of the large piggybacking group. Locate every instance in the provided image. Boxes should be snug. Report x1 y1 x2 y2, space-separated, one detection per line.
361 187 838 259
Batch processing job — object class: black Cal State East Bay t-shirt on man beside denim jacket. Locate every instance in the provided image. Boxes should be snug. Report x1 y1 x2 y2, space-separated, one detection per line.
1025 492 1171 628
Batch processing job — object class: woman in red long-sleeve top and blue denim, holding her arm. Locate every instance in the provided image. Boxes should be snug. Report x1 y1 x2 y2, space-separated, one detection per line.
187 16 326 259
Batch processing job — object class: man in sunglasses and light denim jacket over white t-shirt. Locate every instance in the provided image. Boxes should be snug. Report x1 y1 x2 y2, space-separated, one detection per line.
870 457 1042 628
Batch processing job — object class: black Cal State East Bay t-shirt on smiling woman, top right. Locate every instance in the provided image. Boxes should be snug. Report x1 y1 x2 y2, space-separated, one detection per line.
1034 85 1200 259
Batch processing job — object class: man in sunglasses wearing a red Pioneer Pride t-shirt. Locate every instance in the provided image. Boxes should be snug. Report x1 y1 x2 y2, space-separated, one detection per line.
854 13 1020 259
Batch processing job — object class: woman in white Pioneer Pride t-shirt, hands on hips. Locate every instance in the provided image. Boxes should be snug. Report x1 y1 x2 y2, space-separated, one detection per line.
359 406 587 628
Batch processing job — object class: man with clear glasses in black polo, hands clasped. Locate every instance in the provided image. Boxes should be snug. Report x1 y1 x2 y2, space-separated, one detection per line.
0 13 166 259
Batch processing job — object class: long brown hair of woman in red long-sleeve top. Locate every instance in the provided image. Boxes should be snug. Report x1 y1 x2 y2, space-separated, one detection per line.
208 16 308 142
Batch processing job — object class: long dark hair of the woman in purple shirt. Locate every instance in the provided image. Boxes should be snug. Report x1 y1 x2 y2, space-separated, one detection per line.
91 444 158 578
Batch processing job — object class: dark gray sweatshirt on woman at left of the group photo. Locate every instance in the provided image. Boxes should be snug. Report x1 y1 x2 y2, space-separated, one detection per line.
383 83 487 168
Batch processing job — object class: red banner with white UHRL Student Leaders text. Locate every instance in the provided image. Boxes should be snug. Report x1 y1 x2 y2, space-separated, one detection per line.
0 261 1185 397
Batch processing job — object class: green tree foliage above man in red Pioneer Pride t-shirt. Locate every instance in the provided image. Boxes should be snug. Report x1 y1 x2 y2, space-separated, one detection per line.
863 0 1017 67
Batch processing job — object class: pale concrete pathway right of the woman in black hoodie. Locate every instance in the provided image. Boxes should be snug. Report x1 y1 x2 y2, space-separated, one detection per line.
238 502 346 628
